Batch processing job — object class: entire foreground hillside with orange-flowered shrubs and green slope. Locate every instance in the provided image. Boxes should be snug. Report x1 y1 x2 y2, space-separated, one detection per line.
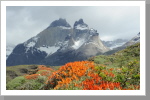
6 43 140 90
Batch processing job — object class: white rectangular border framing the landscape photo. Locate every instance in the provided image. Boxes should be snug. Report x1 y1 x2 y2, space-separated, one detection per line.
1 1 146 96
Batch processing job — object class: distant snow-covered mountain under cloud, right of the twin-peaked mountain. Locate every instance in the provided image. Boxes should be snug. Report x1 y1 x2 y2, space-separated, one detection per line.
102 39 128 50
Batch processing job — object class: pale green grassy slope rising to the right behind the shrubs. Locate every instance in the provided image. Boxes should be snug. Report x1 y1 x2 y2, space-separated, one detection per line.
89 43 140 67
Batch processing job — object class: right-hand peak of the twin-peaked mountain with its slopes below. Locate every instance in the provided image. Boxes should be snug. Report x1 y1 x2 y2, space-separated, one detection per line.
40 19 109 66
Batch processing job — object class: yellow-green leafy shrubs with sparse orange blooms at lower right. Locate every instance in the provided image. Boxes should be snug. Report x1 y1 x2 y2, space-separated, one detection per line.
95 60 140 90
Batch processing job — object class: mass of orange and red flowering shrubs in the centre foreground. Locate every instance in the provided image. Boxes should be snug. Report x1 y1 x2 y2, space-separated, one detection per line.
46 61 122 90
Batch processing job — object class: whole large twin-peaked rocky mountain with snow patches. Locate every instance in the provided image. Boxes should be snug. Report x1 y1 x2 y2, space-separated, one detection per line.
6 18 109 66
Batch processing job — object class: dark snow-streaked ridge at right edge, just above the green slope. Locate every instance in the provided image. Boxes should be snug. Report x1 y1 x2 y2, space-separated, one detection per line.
104 32 140 55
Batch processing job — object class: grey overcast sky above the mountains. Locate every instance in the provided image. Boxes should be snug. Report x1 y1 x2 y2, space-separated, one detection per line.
6 6 140 44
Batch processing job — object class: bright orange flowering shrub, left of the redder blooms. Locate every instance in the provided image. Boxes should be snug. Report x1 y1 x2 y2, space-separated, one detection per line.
46 61 94 89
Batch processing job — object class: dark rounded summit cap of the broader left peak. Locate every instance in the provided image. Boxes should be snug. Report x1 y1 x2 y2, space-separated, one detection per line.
50 18 71 27
